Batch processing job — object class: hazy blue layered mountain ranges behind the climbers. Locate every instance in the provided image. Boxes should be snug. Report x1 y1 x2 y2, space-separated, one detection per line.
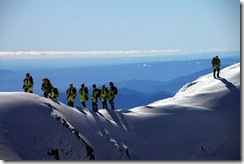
0 56 240 109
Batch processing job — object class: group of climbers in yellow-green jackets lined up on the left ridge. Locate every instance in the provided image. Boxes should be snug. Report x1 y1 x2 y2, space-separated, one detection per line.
23 72 118 112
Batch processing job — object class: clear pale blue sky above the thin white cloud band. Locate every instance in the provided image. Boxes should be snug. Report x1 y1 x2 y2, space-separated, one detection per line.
0 0 240 55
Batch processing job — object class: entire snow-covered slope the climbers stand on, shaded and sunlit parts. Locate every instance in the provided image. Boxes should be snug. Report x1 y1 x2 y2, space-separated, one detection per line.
0 64 241 160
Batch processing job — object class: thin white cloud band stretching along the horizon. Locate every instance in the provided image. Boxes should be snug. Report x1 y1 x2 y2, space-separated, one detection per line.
0 48 240 58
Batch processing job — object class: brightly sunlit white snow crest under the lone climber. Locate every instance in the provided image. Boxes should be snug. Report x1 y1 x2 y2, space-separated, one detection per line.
150 63 240 108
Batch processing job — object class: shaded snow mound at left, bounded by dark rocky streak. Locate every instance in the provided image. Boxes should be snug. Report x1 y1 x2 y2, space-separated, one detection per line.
0 93 92 160
